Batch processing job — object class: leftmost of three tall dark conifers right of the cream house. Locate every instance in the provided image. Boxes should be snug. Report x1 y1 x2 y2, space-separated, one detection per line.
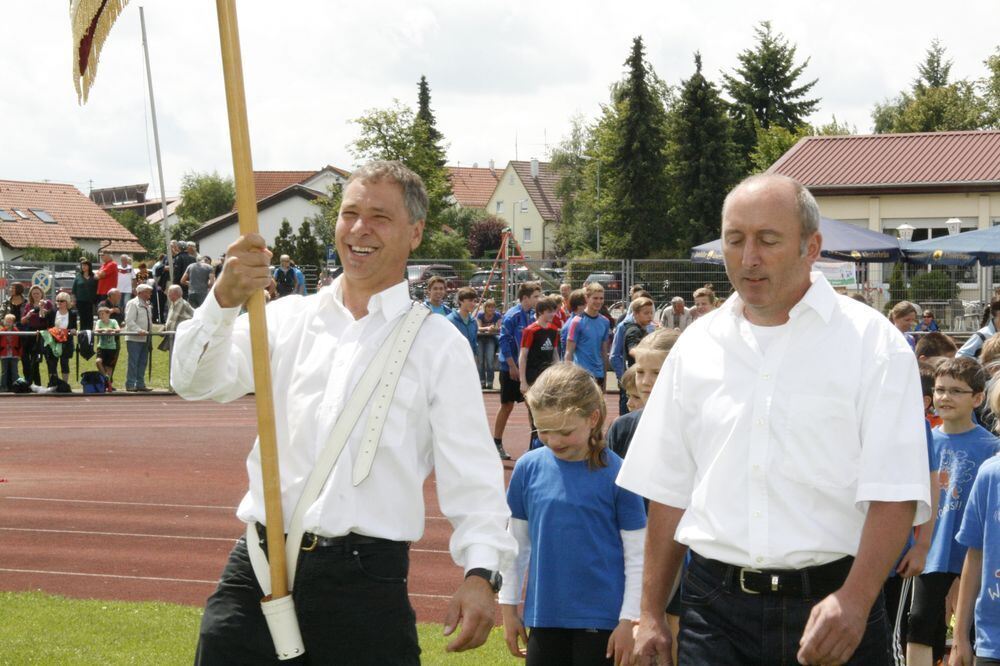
598 37 674 257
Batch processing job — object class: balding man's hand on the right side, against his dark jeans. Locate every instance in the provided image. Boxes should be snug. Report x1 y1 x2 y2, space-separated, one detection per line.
798 589 871 664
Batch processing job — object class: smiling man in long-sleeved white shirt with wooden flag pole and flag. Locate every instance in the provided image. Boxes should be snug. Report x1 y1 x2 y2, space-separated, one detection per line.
71 0 516 664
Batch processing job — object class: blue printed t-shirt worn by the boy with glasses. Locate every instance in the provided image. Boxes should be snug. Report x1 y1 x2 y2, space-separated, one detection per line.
924 426 998 573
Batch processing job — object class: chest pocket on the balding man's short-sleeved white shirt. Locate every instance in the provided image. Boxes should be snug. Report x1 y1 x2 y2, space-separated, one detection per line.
776 394 861 488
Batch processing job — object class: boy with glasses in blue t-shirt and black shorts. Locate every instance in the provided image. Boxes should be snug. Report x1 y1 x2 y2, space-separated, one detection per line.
906 357 997 666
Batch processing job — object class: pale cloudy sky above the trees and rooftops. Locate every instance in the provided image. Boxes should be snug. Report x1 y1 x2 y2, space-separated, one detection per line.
0 0 1000 194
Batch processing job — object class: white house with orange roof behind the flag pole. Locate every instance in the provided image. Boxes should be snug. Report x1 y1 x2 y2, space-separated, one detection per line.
185 165 351 259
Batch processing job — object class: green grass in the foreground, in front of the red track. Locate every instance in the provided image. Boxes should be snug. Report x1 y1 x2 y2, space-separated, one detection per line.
0 592 520 666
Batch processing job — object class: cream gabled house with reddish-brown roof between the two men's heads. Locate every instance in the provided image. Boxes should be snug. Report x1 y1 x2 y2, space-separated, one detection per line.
486 159 562 259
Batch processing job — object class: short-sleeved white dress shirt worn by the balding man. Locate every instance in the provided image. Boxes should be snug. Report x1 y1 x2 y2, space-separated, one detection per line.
618 273 930 569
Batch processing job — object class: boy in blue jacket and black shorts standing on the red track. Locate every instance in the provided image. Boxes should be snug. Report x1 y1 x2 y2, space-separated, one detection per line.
493 282 542 460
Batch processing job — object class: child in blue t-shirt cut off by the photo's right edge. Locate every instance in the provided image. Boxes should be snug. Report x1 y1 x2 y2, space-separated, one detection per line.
949 376 1000 666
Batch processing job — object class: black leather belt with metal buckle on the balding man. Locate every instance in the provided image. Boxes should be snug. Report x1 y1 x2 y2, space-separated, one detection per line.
691 551 854 597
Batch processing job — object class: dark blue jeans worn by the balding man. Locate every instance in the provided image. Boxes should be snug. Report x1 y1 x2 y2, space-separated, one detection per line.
678 558 892 666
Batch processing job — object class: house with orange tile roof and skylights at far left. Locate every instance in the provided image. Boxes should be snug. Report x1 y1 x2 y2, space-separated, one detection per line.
0 180 146 261
